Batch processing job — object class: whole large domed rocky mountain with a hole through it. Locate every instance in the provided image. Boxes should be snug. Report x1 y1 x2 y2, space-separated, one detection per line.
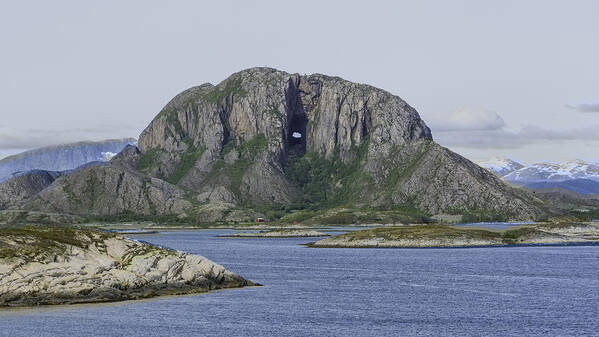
5 68 545 221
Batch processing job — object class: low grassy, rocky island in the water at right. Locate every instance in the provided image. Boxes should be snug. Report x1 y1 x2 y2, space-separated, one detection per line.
309 223 599 248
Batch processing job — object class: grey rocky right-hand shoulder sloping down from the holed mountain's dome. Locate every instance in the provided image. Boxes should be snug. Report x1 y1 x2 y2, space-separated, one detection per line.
363 140 544 218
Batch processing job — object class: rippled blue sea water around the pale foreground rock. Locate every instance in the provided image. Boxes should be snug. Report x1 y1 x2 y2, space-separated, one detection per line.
0 230 599 336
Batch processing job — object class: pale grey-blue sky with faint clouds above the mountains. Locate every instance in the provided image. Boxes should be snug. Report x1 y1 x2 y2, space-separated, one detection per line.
0 0 599 163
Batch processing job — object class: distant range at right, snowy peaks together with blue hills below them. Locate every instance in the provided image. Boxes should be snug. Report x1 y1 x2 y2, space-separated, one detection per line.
478 158 599 195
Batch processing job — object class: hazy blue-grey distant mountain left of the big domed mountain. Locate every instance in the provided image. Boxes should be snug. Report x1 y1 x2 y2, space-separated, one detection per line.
0 138 136 181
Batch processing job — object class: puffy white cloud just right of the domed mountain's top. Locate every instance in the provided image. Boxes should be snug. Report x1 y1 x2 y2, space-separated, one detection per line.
429 108 505 131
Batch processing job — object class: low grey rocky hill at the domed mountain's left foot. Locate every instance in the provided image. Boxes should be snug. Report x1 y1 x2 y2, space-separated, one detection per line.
21 146 191 215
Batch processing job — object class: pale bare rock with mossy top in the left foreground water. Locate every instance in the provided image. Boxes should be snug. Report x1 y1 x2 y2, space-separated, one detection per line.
0 228 253 307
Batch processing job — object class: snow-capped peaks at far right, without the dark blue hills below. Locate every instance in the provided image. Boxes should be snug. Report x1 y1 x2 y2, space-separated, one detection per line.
504 159 599 182
